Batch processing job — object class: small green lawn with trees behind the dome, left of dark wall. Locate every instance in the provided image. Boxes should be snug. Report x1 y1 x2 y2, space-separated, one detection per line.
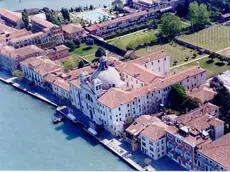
70 44 99 57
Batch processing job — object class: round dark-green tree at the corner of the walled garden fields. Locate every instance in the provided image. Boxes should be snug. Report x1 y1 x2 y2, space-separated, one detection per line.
160 13 182 37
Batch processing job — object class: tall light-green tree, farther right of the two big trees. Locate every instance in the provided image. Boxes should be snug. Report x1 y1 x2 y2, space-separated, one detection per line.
188 1 210 28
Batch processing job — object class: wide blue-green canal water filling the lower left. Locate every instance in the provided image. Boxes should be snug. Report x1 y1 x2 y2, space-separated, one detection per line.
0 83 132 170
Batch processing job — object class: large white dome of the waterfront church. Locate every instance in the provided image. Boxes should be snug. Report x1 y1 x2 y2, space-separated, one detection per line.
92 66 123 89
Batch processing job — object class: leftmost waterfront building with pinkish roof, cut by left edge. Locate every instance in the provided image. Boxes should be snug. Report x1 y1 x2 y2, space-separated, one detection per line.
0 45 44 72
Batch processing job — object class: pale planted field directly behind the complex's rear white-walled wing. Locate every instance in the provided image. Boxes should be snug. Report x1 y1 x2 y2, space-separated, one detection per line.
136 42 203 66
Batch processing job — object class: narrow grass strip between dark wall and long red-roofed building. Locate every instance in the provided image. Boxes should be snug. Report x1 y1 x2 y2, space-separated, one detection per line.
107 30 156 50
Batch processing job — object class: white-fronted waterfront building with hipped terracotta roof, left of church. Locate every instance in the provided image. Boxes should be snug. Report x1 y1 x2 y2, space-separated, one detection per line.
20 56 62 88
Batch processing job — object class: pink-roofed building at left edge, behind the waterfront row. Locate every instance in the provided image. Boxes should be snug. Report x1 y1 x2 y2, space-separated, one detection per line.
0 24 31 43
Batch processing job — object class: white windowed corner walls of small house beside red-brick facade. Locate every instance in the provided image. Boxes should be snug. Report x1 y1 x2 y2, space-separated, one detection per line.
140 134 166 160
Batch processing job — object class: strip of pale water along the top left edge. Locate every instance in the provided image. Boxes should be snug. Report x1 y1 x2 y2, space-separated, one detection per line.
0 0 115 10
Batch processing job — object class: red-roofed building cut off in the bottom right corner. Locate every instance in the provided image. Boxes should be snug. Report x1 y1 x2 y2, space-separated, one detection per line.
195 133 230 171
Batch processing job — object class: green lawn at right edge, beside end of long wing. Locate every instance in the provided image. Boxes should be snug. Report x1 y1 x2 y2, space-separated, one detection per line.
171 58 230 78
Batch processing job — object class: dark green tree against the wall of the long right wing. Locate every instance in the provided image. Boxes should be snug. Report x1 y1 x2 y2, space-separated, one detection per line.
169 84 188 109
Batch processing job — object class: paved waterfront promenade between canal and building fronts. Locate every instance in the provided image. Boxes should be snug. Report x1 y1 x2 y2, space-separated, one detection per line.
0 71 185 171
